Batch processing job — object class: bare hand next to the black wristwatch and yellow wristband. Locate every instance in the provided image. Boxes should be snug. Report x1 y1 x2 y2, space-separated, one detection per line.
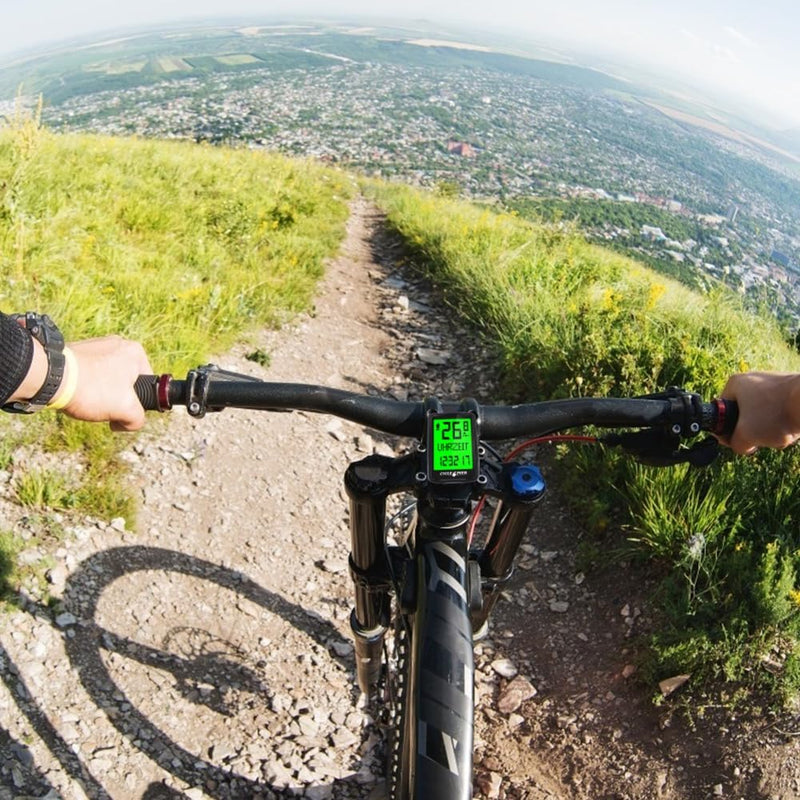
54 336 152 431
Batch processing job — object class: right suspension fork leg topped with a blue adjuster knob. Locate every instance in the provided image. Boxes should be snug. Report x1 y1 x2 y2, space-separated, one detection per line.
472 464 545 638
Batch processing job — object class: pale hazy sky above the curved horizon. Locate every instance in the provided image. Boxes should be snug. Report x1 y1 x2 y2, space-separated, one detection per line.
0 0 800 126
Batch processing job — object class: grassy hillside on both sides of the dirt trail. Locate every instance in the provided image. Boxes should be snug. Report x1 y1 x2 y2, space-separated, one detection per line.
0 130 800 796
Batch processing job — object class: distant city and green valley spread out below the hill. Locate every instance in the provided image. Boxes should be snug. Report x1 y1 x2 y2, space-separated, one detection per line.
0 20 800 334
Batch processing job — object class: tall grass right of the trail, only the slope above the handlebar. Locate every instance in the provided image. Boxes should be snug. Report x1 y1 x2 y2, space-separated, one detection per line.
371 180 799 398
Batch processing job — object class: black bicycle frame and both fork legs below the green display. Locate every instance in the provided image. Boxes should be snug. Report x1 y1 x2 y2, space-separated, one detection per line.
345 428 544 798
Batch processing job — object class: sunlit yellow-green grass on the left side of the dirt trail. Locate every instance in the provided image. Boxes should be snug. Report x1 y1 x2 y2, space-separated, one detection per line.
0 116 352 556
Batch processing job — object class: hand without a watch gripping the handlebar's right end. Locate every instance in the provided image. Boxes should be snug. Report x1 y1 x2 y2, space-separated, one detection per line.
720 372 800 454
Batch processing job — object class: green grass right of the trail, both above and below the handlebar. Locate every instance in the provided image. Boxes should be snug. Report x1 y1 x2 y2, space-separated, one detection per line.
365 183 800 699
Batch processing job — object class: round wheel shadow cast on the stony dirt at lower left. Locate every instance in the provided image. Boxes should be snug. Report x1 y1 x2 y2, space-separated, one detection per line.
28 546 378 798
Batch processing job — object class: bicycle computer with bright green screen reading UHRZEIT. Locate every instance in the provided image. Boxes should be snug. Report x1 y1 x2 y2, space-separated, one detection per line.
425 412 480 483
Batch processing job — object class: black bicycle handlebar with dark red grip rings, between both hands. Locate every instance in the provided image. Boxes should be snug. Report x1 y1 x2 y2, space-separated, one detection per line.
135 365 738 441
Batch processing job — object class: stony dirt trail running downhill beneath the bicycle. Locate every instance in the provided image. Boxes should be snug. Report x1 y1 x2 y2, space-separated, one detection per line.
0 200 800 800
